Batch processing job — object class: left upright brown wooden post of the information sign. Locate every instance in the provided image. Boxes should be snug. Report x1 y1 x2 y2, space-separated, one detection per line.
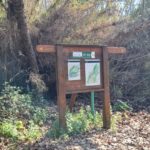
56 46 66 129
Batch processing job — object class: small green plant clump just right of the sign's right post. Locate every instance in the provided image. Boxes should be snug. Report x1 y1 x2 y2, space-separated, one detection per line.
113 100 132 111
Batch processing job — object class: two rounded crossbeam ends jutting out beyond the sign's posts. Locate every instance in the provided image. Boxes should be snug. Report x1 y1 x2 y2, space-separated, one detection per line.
36 45 126 54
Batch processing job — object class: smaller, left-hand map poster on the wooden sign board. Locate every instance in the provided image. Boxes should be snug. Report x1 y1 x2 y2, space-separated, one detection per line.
68 60 81 81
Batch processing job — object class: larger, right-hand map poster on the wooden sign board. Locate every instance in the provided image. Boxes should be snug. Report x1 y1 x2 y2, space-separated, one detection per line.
85 59 101 86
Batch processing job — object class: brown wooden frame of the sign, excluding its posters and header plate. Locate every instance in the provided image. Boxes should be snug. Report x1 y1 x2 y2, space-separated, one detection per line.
36 44 126 129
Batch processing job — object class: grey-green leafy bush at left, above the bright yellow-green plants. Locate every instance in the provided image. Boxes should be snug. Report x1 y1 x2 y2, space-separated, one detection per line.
0 84 48 124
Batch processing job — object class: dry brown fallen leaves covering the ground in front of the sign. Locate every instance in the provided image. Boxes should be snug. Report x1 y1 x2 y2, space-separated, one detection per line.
14 112 150 150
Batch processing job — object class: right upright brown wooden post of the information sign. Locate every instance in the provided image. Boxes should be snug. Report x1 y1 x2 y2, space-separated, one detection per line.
103 47 111 129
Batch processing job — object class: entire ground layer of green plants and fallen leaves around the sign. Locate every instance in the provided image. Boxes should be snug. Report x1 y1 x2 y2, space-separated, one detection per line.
0 84 150 150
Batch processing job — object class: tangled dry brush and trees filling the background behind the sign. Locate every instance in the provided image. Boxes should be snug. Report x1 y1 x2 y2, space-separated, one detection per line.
0 0 150 102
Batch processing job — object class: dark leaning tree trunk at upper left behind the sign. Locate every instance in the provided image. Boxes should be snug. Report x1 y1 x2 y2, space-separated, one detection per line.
8 0 39 73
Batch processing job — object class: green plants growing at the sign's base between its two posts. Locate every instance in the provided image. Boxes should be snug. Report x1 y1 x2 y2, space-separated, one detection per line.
48 107 102 138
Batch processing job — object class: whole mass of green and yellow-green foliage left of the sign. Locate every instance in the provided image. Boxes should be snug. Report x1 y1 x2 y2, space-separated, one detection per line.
0 84 48 141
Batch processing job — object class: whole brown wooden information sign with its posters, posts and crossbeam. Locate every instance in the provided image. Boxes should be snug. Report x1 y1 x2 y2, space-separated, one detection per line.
36 44 126 129
